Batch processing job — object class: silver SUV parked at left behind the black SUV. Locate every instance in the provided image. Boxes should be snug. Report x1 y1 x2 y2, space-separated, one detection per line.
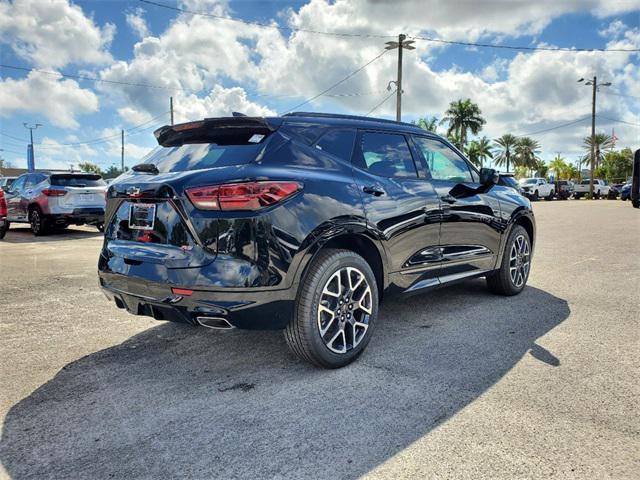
6 172 105 235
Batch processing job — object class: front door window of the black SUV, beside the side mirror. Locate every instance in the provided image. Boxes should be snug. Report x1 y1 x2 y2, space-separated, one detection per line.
413 137 474 183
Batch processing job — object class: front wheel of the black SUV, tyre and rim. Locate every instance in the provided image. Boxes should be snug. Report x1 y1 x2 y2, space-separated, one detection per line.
487 225 531 295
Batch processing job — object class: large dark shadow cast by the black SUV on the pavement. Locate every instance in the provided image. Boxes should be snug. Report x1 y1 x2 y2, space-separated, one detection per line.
0 280 569 479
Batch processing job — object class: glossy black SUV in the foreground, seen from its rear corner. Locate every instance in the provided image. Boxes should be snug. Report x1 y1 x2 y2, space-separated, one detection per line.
99 113 535 368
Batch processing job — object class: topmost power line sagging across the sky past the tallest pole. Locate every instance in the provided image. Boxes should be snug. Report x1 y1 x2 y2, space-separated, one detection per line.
139 0 640 52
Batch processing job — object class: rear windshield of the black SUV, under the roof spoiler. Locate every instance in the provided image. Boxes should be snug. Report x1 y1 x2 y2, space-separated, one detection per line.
142 142 264 173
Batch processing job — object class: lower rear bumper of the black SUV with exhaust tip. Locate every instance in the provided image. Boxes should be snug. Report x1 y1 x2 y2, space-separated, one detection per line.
99 272 295 330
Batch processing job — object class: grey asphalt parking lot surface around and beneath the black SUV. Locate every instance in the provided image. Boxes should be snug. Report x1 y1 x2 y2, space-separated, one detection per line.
0 200 640 479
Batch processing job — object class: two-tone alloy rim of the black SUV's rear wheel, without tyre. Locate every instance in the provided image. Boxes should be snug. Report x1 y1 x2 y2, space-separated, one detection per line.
318 267 373 354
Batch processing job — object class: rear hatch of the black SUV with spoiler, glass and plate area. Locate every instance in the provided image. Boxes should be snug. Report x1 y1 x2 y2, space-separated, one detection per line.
104 117 282 273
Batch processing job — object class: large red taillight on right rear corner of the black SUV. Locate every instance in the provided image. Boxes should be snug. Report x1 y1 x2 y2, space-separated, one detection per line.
186 181 302 210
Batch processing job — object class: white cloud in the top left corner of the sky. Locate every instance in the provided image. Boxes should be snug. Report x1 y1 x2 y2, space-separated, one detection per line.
0 0 115 68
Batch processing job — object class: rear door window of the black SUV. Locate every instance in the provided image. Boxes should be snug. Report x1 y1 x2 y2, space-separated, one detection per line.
355 132 418 178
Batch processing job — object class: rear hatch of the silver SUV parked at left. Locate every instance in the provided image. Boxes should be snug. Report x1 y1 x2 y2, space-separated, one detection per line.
49 173 107 209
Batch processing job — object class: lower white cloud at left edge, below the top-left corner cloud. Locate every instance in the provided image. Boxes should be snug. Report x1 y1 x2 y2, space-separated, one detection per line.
0 72 98 128
